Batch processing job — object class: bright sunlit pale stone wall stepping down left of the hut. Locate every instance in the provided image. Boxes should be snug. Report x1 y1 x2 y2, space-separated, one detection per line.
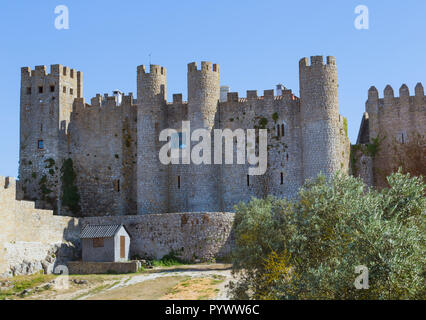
0 177 80 277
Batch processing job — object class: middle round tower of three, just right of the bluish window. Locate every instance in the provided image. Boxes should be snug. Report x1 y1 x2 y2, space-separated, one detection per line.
186 61 220 211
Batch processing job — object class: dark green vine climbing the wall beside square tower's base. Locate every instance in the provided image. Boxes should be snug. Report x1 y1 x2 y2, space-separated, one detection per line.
61 158 81 214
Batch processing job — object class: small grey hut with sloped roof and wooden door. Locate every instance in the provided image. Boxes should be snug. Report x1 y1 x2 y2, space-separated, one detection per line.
80 225 130 262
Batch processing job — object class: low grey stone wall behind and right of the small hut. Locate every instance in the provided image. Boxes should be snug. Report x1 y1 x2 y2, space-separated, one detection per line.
81 212 234 261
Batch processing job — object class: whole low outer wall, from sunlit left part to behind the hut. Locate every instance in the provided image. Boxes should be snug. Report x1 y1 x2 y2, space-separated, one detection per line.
0 177 234 278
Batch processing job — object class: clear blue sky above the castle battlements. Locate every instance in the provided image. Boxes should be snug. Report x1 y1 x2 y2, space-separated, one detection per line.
0 0 426 176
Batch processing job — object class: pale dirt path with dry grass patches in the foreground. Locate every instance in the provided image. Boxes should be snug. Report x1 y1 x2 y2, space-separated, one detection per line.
18 264 232 300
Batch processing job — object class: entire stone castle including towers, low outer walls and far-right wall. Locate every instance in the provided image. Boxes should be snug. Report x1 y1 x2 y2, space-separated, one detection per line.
0 56 426 276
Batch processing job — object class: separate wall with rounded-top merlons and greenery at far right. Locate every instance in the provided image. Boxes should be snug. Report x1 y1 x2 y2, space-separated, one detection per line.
352 83 426 187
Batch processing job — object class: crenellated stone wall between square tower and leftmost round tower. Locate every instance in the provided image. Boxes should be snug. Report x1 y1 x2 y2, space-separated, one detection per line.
68 94 137 216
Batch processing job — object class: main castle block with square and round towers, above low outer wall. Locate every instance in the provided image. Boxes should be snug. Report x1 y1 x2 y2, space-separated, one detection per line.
19 56 350 217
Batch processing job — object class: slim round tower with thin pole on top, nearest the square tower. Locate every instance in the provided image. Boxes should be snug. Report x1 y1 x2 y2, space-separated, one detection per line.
137 65 168 214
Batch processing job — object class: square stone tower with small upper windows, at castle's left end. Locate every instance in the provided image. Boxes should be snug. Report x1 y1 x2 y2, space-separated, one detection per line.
19 64 83 214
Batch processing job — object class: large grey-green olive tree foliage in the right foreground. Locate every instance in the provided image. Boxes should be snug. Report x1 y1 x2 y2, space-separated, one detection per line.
230 171 426 299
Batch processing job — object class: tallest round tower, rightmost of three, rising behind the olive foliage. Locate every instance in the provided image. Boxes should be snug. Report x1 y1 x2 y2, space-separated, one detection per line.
299 56 342 179
